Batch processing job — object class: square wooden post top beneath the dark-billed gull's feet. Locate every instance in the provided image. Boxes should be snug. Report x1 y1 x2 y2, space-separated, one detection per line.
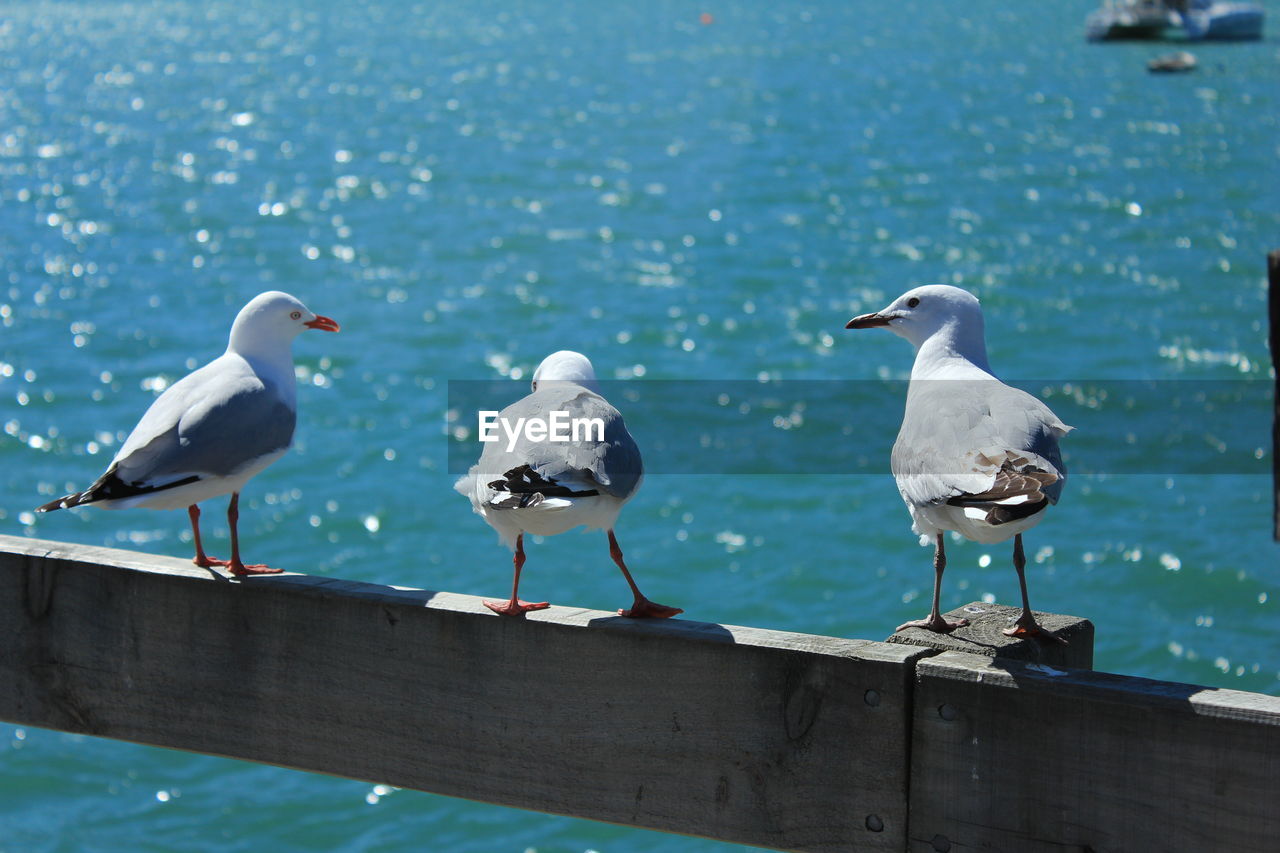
888 601 1093 670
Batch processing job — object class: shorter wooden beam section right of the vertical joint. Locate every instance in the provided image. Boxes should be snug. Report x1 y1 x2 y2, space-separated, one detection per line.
909 652 1280 853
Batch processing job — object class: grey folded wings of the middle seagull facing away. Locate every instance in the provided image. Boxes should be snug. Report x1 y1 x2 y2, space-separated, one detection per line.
476 382 644 500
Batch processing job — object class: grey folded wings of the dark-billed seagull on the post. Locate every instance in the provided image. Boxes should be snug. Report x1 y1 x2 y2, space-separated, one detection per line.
891 379 1070 506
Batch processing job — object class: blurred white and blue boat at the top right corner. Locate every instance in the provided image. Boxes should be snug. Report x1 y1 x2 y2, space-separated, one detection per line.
1084 0 1265 41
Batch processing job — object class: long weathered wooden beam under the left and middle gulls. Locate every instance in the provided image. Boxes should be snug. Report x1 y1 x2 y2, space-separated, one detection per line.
0 537 929 850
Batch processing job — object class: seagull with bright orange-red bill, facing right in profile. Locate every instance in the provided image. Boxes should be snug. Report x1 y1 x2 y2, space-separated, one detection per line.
36 291 339 575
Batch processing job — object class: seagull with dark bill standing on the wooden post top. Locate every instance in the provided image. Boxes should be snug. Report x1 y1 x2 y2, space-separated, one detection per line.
845 284 1071 642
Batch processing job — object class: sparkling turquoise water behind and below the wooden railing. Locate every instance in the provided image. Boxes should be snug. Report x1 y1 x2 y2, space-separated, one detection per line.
0 0 1280 853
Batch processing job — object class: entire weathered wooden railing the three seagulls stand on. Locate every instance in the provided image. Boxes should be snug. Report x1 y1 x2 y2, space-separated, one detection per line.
0 537 1280 850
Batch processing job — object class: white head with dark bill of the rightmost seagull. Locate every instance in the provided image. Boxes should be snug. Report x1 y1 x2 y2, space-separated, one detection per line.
845 284 987 353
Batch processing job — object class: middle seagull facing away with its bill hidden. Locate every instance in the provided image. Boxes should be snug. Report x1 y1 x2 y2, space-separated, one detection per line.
453 350 684 619
